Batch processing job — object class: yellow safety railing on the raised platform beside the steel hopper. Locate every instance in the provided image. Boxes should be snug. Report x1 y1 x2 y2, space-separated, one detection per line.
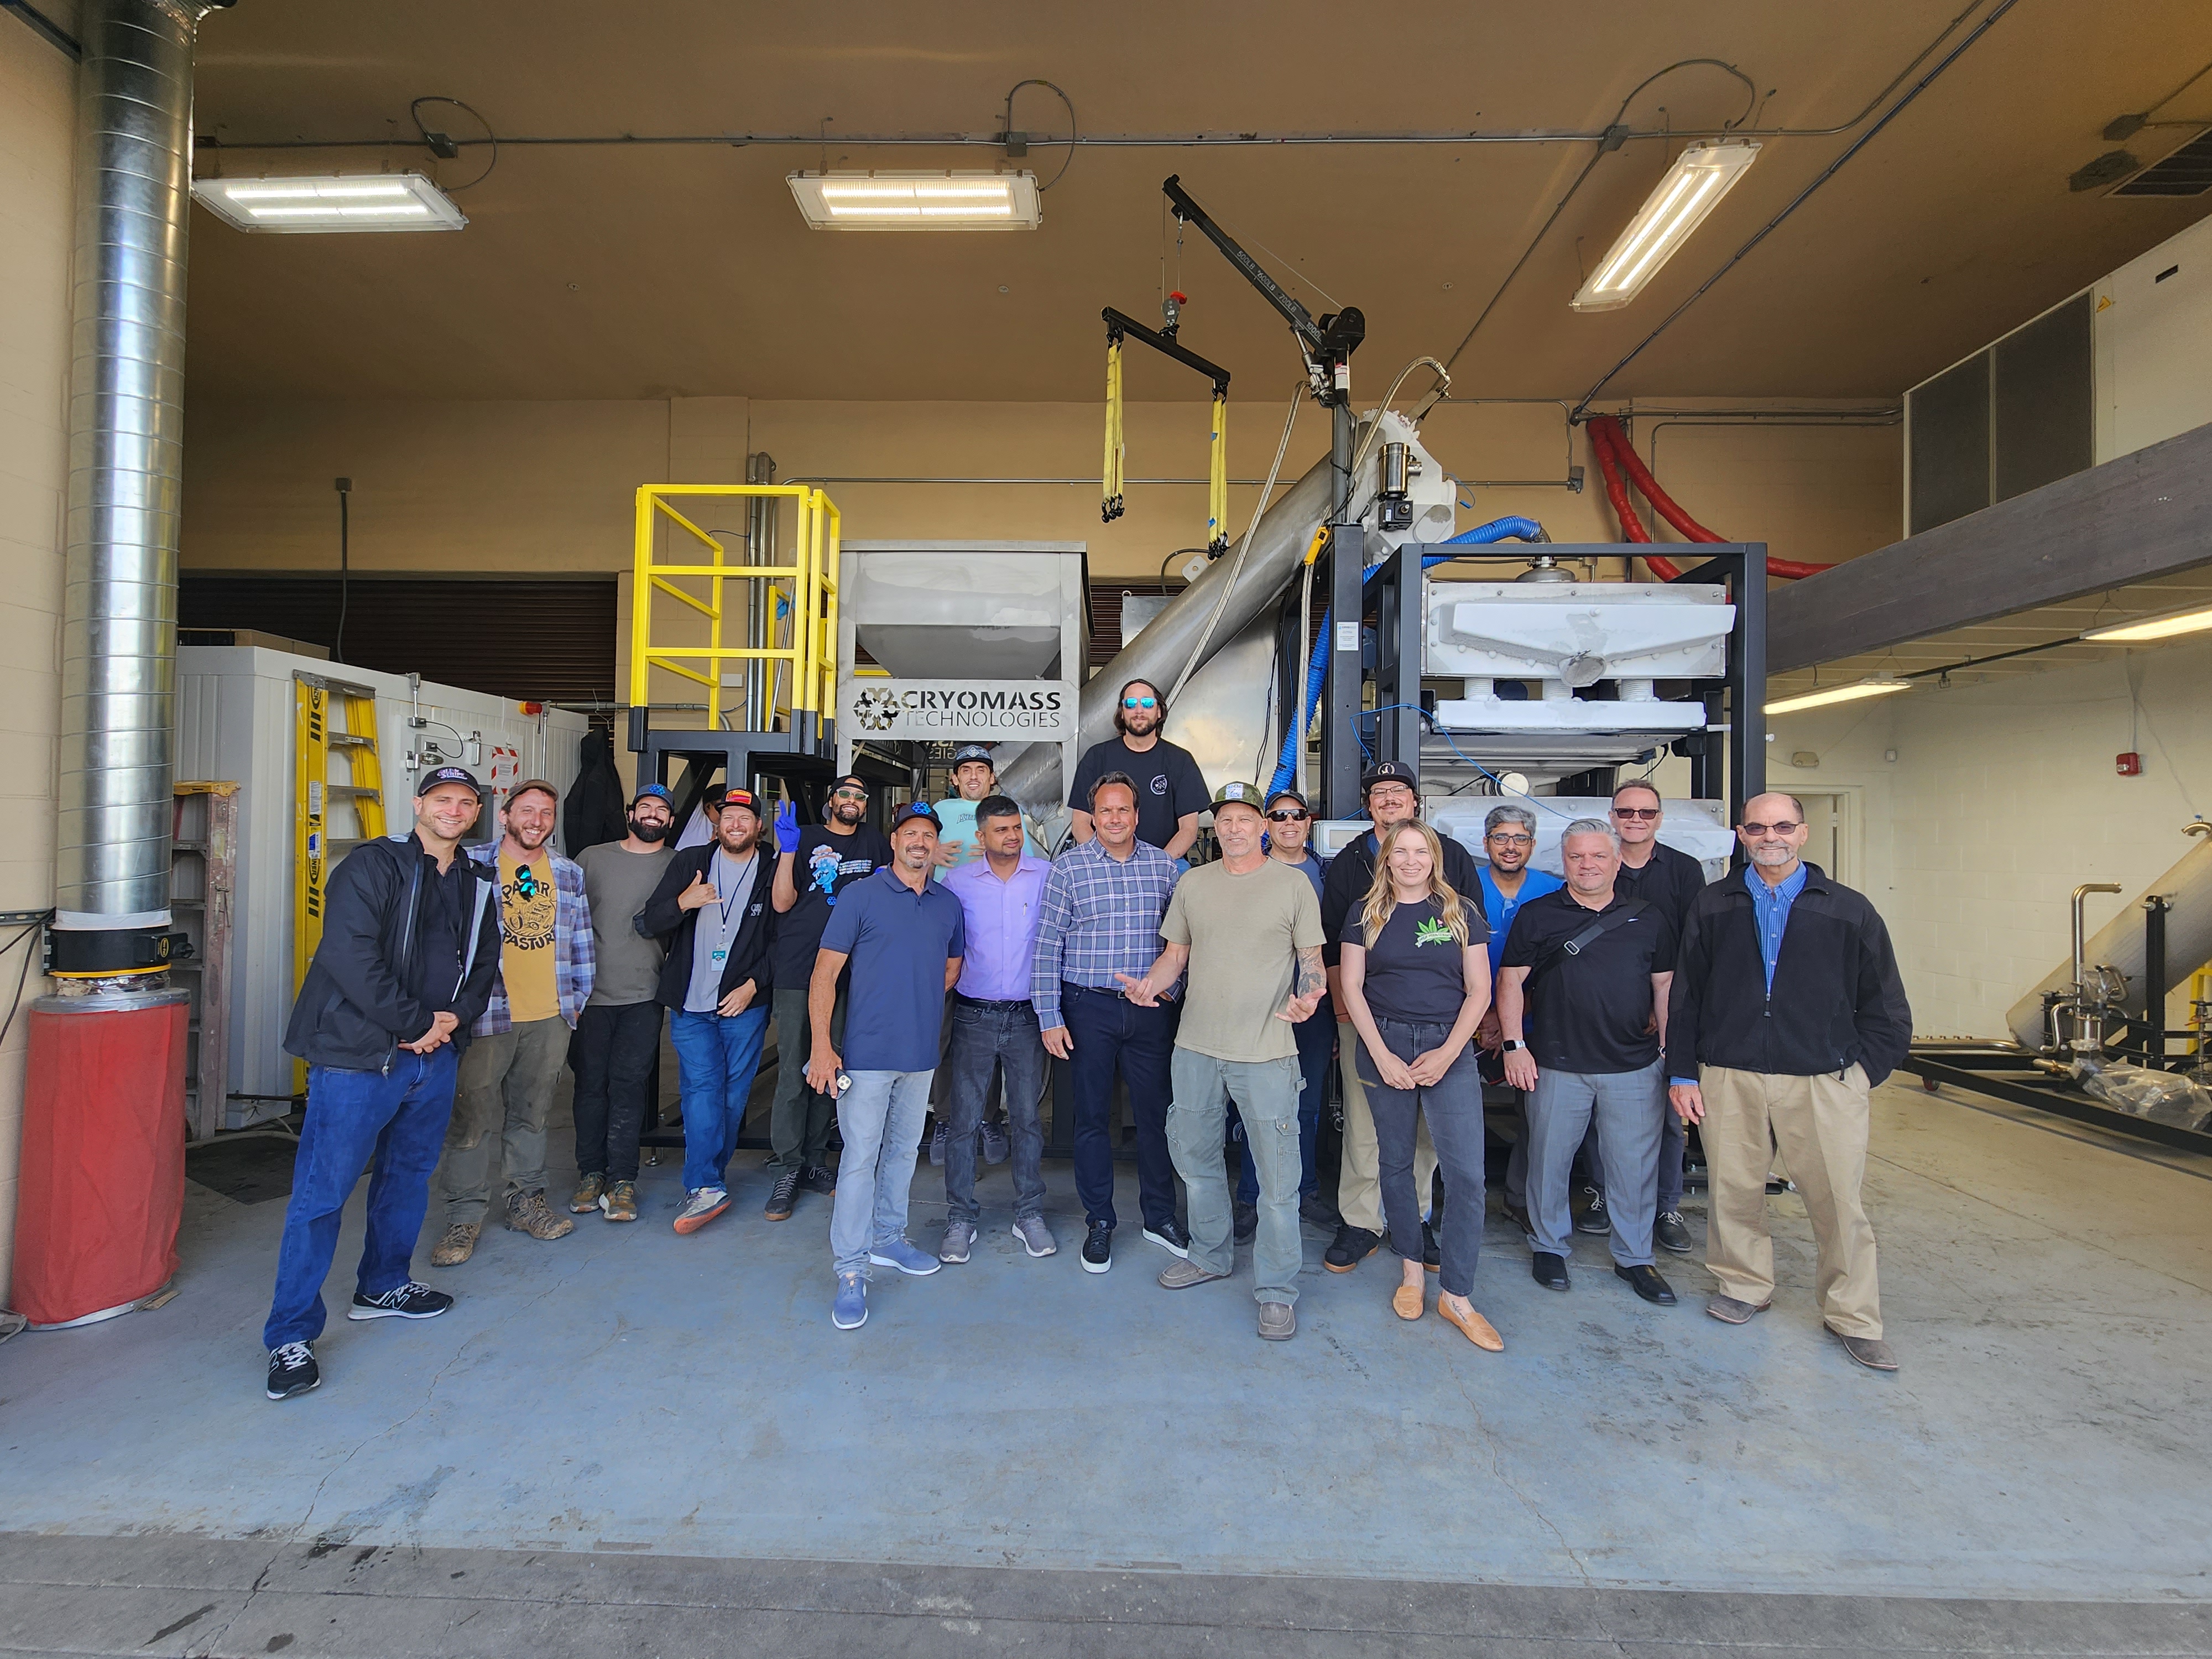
630 484 843 726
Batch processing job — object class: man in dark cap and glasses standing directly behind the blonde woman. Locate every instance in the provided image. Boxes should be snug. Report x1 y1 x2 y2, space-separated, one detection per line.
1321 761 1482 1274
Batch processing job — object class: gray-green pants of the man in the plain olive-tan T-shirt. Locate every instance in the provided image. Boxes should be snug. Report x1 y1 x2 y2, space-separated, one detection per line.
1168 1046 1305 1303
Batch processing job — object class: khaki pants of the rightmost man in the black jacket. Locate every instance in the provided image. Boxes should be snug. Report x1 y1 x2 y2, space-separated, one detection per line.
1697 1066 1882 1336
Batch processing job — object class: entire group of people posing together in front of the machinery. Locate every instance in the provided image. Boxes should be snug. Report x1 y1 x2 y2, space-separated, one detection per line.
265 681 1911 1398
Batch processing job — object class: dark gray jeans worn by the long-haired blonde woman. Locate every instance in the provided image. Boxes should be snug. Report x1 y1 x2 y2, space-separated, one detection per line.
1360 1015 1482 1296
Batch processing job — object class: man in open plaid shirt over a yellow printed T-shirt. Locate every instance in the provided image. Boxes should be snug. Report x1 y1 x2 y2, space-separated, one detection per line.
429 779 595 1267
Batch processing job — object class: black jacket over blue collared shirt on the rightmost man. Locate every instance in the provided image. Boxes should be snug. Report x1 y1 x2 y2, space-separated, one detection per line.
1666 865 1913 1084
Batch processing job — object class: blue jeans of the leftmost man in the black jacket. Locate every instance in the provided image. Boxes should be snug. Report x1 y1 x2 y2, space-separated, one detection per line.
261 1042 460 1347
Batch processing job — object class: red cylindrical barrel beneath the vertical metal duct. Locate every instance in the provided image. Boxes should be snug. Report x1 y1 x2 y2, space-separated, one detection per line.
13 991 190 1325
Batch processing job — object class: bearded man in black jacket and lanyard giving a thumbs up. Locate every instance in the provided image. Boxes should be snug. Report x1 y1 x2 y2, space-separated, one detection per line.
637 790 776 1232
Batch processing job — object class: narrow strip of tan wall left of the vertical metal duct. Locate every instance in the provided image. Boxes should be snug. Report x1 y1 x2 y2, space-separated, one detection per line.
0 18 75 1303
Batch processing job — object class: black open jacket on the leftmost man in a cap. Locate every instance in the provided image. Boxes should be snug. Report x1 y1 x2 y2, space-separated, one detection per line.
283 832 500 1071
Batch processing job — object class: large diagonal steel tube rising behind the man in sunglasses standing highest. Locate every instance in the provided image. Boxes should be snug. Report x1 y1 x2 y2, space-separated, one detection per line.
1000 420 1376 814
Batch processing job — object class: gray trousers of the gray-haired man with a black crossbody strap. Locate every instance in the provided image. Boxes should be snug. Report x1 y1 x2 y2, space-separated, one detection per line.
1528 1057 1668 1267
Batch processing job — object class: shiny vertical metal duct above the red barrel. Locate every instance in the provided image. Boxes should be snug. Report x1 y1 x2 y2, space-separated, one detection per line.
55 0 212 973
